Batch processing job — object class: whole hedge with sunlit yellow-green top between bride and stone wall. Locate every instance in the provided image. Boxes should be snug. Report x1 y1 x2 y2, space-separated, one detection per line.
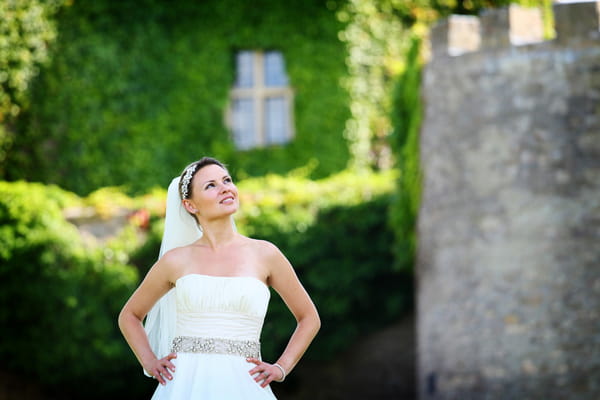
236 170 412 360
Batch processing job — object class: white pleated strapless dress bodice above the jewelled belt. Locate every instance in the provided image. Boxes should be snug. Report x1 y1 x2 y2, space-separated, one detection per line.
175 274 270 341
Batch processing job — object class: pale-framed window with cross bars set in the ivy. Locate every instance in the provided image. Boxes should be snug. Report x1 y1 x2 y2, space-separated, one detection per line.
228 51 294 150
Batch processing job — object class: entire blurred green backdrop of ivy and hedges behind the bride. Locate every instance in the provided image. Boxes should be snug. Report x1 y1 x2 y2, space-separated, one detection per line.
0 0 551 399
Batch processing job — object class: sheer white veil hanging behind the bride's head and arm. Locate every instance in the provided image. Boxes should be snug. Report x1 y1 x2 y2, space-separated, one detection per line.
144 177 202 376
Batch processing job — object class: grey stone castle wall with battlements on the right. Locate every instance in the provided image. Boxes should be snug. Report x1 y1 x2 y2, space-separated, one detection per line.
417 2 600 400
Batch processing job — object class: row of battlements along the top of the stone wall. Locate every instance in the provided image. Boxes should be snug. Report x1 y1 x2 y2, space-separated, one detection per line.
430 1 600 58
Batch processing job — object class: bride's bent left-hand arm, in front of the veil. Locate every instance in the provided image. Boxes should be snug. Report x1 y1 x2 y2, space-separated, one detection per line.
119 253 176 385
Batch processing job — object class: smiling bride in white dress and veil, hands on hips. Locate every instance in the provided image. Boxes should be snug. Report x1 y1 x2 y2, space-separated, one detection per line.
119 157 320 399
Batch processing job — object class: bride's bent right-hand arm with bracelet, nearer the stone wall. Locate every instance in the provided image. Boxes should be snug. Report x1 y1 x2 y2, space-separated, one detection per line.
250 242 321 386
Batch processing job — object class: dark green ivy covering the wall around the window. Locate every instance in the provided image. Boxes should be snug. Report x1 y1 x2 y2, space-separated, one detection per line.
5 0 349 194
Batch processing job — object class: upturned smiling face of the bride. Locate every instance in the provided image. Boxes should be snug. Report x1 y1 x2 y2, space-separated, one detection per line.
184 164 239 220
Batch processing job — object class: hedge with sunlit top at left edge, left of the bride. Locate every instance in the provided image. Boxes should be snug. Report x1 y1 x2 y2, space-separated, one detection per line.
0 182 152 399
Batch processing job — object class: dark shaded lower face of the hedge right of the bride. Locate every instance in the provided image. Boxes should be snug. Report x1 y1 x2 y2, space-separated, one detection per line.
263 195 412 360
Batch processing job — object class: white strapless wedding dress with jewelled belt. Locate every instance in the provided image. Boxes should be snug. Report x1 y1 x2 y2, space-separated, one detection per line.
152 274 275 400
